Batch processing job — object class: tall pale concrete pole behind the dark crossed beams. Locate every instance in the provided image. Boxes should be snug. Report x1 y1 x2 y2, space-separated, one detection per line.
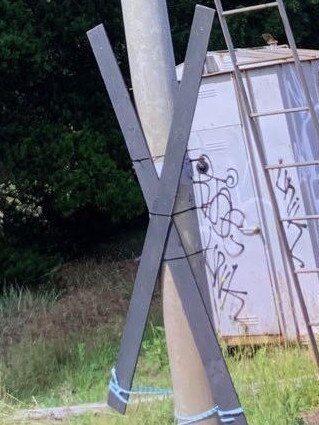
121 0 220 425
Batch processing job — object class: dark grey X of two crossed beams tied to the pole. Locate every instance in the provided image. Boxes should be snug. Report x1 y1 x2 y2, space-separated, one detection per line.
87 6 247 425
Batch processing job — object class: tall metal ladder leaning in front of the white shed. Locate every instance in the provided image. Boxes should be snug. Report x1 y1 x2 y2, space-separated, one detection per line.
214 0 319 369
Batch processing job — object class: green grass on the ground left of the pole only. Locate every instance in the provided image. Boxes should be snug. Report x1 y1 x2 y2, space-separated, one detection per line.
0 320 173 425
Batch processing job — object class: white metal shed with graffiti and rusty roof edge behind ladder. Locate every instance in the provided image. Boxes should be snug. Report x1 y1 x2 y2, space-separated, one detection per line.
177 46 319 343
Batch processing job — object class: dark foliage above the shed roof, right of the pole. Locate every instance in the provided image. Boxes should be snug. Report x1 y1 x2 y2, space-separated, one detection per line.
167 0 319 63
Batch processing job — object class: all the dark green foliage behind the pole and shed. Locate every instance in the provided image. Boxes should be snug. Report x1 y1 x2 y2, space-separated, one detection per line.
0 0 319 281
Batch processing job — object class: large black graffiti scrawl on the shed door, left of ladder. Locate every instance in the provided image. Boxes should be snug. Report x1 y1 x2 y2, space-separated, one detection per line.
194 155 247 320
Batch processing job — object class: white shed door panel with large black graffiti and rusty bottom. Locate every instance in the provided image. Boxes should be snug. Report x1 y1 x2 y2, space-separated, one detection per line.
189 125 279 336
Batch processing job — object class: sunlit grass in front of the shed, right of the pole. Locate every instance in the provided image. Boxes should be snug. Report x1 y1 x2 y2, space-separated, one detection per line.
227 346 319 425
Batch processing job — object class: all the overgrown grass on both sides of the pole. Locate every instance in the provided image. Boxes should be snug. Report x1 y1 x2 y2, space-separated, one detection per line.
0 264 319 425
